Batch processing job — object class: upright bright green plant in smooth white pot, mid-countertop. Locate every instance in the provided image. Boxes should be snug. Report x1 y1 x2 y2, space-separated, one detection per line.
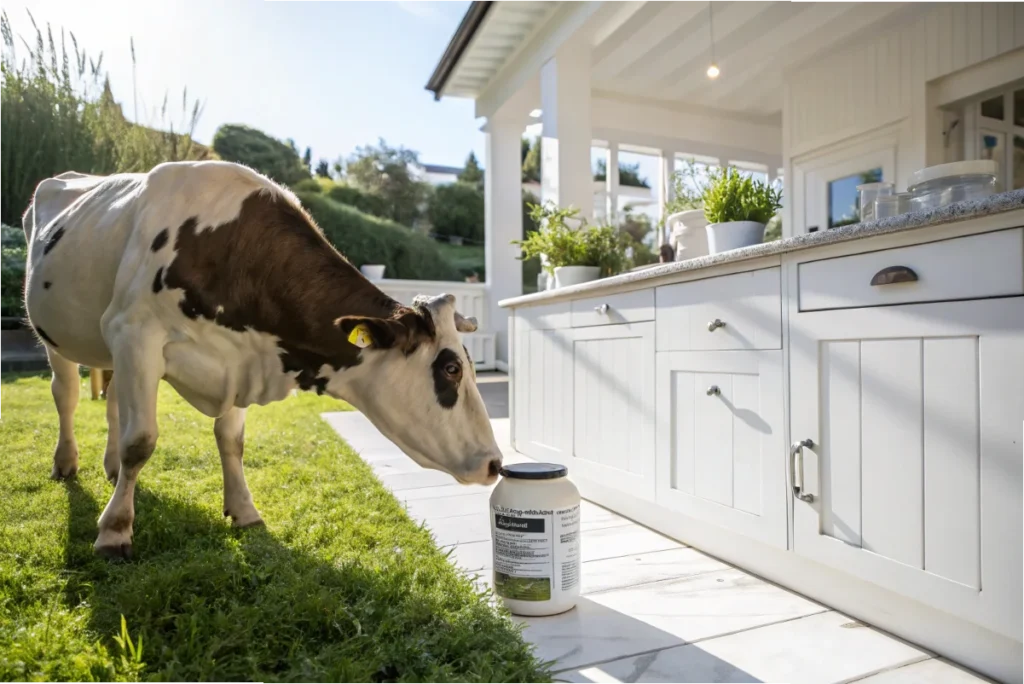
701 168 782 254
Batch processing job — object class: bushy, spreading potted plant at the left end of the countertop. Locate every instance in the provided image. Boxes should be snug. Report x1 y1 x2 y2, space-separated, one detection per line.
512 203 626 288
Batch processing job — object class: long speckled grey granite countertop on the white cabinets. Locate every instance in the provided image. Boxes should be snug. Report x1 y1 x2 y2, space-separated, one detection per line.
499 184 1024 307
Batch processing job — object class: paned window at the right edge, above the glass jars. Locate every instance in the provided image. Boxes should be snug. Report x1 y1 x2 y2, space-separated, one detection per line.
963 86 1024 189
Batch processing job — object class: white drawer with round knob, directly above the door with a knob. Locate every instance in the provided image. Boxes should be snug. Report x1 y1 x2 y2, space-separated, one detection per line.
655 266 782 351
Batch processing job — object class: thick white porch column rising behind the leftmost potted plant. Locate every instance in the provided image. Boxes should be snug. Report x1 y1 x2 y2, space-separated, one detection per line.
541 40 594 220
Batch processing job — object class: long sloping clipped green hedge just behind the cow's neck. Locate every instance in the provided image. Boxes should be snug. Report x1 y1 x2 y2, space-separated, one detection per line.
296 191 463 281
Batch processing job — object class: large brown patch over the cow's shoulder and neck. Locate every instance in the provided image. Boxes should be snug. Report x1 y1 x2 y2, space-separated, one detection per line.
164 191 432 392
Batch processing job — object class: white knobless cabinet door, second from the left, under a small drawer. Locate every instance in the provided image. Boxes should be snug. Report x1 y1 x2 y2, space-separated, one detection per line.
569 323 654 501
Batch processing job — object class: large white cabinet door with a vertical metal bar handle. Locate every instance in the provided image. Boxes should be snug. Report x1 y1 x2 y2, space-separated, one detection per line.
790 298 1024 641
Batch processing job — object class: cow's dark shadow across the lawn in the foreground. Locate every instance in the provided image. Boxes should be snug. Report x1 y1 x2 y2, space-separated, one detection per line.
65 480 548 682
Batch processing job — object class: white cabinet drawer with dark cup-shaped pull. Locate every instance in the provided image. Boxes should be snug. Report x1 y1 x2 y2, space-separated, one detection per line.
798 228 1024 311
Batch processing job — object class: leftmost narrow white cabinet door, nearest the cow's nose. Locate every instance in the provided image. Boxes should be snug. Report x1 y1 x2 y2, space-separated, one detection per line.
512 316 572 466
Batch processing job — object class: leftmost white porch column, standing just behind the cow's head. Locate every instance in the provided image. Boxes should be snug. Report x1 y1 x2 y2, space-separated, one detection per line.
483 119 523 364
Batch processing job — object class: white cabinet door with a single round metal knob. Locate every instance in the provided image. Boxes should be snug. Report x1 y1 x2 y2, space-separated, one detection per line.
657 351 787 549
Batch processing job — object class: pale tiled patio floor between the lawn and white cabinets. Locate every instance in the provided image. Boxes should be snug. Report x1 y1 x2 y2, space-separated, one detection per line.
324 374 988 684
